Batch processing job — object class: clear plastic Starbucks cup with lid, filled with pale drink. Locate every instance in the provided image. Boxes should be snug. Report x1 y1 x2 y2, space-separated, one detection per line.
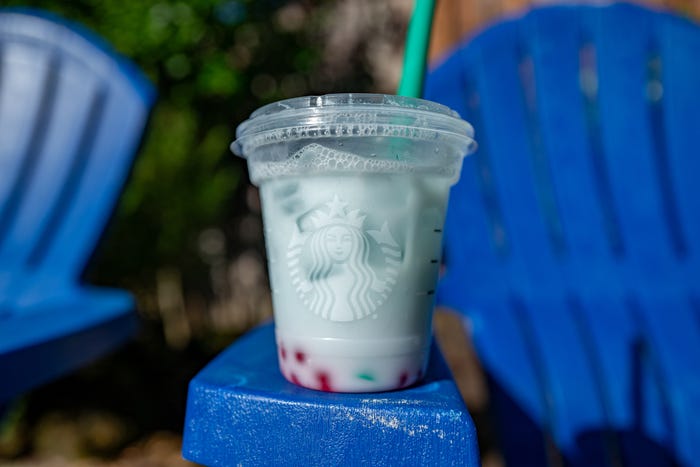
231 94 474 392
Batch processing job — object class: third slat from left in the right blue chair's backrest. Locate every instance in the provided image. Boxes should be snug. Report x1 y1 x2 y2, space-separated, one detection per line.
523 7 614 291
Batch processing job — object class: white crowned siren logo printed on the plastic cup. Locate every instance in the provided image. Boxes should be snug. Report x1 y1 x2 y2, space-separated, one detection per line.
287 195 402 321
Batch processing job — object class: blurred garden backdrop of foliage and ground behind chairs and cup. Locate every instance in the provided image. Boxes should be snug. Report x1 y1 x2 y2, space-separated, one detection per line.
0 0 700 466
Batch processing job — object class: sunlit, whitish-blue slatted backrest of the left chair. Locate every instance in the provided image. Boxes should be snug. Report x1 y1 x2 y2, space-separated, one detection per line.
0 10 154 308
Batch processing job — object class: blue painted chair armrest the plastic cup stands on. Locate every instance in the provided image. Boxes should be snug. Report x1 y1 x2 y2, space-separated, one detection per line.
183 324 479 466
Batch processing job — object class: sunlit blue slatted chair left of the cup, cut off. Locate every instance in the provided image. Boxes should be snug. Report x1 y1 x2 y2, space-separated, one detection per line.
0 10 154 405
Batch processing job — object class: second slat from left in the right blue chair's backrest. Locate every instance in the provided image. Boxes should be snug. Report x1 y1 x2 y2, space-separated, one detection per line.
474 24 561 295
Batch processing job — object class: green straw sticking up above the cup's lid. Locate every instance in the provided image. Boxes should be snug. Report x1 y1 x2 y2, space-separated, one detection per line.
398 0 435 97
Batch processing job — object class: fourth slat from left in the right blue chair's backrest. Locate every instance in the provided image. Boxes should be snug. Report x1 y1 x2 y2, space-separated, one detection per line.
588 5 675 285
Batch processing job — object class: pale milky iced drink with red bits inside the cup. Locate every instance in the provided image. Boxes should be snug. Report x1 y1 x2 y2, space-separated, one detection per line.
259 144 449 392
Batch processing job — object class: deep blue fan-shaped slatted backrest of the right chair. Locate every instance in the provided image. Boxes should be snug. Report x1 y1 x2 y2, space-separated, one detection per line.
426 4 700 308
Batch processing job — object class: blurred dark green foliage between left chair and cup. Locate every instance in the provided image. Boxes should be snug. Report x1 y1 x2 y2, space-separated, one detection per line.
6 0 317 288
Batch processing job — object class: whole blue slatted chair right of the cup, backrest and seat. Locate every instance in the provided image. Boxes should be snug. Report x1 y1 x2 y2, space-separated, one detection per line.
426 4 700 466
